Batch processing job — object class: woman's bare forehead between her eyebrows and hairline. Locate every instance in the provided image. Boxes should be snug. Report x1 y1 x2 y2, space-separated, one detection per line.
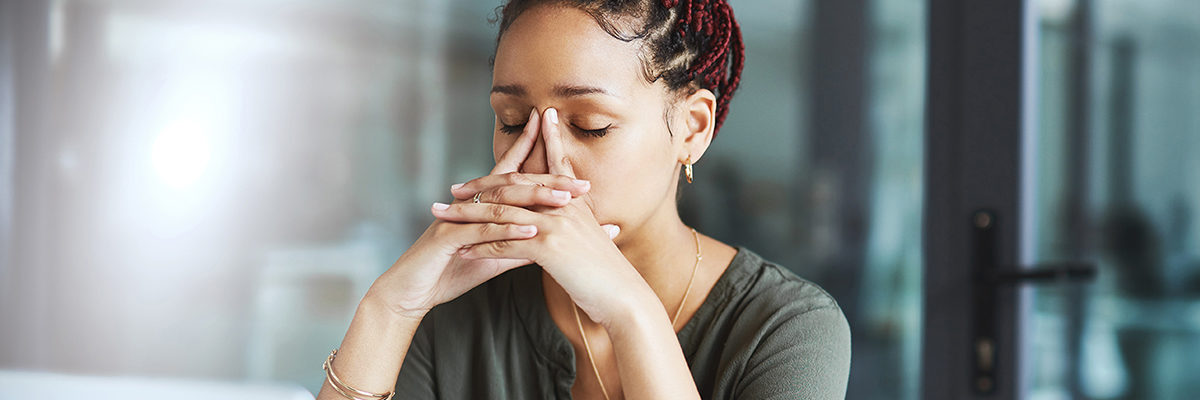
492 6 649 96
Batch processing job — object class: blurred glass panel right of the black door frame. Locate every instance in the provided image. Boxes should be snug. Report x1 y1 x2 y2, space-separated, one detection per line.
1025 0 1200 399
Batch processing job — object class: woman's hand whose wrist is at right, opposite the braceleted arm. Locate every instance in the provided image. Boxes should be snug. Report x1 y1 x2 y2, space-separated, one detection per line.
434 108 656 327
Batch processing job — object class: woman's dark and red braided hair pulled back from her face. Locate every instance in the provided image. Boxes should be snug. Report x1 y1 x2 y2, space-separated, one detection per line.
497 0 745 136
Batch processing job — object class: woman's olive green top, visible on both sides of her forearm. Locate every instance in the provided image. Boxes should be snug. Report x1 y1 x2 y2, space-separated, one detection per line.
396 246 850 399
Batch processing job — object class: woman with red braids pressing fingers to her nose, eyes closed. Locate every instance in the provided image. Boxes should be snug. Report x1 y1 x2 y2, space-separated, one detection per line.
319 0 850 399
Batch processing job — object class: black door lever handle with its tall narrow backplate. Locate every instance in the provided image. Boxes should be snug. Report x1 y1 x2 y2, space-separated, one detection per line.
971 209 1096 395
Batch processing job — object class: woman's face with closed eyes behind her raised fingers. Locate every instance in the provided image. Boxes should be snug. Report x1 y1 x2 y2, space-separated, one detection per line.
491 6 688 244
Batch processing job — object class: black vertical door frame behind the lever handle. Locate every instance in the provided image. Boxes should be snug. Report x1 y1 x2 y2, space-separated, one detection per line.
922 0 1037 400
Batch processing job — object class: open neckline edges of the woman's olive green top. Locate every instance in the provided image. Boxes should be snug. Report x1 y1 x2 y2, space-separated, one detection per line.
509 245 758 372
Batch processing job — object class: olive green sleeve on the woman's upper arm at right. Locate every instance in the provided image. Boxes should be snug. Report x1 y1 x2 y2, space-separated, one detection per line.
734 305 850 399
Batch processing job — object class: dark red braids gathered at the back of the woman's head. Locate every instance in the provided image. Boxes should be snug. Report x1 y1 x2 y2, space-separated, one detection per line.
662 0 745 136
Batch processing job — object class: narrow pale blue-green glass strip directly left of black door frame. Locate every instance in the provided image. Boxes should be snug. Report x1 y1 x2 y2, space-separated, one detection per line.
851 0 926 399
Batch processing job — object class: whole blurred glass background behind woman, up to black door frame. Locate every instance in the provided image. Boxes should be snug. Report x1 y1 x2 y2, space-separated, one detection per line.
0 0 926 399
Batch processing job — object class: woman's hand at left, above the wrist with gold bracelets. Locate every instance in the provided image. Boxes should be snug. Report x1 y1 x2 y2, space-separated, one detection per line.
365 109 589 320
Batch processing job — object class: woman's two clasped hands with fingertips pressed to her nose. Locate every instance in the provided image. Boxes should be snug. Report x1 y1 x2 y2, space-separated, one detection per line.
417 108 653 324
